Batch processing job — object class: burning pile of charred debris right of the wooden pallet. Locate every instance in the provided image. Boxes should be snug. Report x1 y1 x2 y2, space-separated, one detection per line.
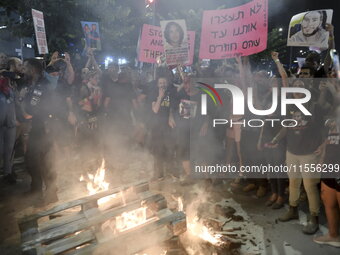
166 184 263 255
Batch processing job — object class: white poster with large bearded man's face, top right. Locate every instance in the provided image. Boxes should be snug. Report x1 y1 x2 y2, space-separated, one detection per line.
287 10 333 49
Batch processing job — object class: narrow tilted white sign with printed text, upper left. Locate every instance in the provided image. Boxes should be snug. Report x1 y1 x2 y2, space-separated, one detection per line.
32 9 48 54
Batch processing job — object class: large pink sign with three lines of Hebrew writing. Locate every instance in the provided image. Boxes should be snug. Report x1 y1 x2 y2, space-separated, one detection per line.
199 0 268 59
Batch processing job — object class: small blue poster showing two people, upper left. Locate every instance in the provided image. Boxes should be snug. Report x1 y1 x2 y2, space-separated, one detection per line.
80 21 101 50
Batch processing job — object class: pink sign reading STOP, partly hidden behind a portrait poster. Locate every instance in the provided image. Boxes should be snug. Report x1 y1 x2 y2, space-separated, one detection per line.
138 24 195 65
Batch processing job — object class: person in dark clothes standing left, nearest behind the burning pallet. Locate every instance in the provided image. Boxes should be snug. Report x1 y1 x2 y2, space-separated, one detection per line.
24 59 58 202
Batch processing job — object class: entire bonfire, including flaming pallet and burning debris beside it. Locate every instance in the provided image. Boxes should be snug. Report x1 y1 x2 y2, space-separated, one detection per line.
19 160 264 255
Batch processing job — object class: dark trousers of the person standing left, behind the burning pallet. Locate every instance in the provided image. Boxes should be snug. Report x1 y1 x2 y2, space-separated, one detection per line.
25 132 56 192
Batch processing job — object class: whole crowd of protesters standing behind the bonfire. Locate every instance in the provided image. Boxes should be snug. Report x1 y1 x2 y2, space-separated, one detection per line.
0 25 340 247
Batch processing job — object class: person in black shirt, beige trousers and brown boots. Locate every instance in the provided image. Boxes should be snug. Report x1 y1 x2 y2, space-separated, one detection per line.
271 79 323 234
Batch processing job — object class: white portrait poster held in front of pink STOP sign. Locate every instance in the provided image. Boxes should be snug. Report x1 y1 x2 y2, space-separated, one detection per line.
161 20 189 65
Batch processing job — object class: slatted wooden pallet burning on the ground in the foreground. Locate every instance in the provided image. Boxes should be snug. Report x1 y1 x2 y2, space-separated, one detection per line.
19 182 186 254
